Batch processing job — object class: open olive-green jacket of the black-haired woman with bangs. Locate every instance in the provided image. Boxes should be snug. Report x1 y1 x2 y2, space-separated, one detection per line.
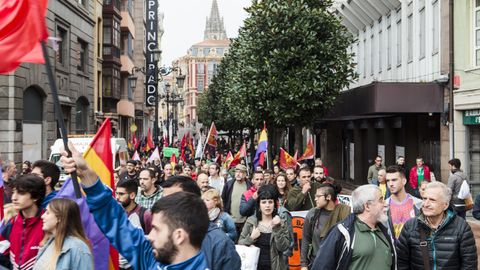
238 216 291 270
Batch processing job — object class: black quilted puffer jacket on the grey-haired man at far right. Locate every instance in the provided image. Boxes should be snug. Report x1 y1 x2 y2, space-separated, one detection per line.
397 210 477 270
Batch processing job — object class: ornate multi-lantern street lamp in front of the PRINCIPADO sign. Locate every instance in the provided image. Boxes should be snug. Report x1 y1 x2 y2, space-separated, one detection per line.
128 55 185 145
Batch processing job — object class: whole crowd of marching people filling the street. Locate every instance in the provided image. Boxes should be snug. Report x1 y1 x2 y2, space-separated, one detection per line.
0 147 480 270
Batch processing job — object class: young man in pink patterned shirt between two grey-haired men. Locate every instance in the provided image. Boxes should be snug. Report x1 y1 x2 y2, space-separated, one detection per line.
385 165 422 239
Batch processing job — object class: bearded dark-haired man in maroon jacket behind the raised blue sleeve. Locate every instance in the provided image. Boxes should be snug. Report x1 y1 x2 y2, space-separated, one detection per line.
115 180 152 270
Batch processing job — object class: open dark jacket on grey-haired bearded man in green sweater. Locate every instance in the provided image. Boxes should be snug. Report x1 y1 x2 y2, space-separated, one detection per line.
312 214 396 270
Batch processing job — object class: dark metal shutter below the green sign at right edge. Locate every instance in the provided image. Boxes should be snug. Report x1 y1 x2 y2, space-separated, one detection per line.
469 126 480 197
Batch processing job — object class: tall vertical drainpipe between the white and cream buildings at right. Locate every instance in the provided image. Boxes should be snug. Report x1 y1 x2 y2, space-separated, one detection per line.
448 0 455 159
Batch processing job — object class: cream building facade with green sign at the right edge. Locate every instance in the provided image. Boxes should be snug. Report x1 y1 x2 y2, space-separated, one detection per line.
454 0 480 194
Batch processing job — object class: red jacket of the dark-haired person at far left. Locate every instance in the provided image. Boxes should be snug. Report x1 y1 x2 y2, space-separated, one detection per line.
2 210 44 270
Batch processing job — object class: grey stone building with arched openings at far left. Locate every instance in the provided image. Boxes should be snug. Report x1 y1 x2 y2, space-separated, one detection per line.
0 0 97 162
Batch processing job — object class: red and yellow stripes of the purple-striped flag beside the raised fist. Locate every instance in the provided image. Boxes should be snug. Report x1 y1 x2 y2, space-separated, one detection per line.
83 118 119 270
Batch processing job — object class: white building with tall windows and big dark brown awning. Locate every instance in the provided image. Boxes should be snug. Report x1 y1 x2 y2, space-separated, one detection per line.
322 0 451 184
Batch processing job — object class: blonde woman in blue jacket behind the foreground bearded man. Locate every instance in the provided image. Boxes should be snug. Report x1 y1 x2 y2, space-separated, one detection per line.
202 189 237 242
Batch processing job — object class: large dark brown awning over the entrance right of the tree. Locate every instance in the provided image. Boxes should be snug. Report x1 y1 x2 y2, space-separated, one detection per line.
322 82 444 120
